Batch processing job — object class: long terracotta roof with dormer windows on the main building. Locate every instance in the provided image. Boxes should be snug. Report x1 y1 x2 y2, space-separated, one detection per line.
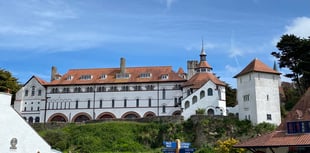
48 66 186 85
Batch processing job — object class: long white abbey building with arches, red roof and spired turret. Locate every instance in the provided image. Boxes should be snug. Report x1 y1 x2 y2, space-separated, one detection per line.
15 49 226 122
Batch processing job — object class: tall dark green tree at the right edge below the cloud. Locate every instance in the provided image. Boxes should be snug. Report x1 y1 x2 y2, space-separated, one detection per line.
271 35 310 95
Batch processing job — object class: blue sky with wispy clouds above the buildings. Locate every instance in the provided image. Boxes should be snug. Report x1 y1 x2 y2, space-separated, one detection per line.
0 0 310 87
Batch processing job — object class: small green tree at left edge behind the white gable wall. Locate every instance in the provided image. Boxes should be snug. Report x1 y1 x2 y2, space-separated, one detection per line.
0 69 21 102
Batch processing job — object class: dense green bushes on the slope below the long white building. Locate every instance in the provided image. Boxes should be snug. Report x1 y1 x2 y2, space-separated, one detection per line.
35 117 274 153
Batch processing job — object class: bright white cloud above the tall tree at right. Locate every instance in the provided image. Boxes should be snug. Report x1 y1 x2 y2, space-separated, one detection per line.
285 17 310 38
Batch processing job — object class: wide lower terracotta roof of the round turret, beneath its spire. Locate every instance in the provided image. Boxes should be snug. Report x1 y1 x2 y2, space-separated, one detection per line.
183 73 226 89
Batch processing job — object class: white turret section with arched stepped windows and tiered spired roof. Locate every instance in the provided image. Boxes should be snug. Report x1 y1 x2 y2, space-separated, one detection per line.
181 48 227 119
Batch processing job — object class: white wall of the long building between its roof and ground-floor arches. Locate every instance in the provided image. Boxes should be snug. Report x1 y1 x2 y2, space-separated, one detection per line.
41 82 182 122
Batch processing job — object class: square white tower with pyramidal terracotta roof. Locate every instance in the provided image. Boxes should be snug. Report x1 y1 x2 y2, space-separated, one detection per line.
234 59 281 125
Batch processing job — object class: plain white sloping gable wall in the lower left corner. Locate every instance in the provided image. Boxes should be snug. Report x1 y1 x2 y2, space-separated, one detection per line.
0 93 57 153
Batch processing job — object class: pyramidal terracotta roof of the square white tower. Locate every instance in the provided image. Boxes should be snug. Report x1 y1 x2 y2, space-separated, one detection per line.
234 59 281 78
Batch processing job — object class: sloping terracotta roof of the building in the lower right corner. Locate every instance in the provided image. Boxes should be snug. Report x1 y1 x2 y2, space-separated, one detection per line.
234 88 310 148
